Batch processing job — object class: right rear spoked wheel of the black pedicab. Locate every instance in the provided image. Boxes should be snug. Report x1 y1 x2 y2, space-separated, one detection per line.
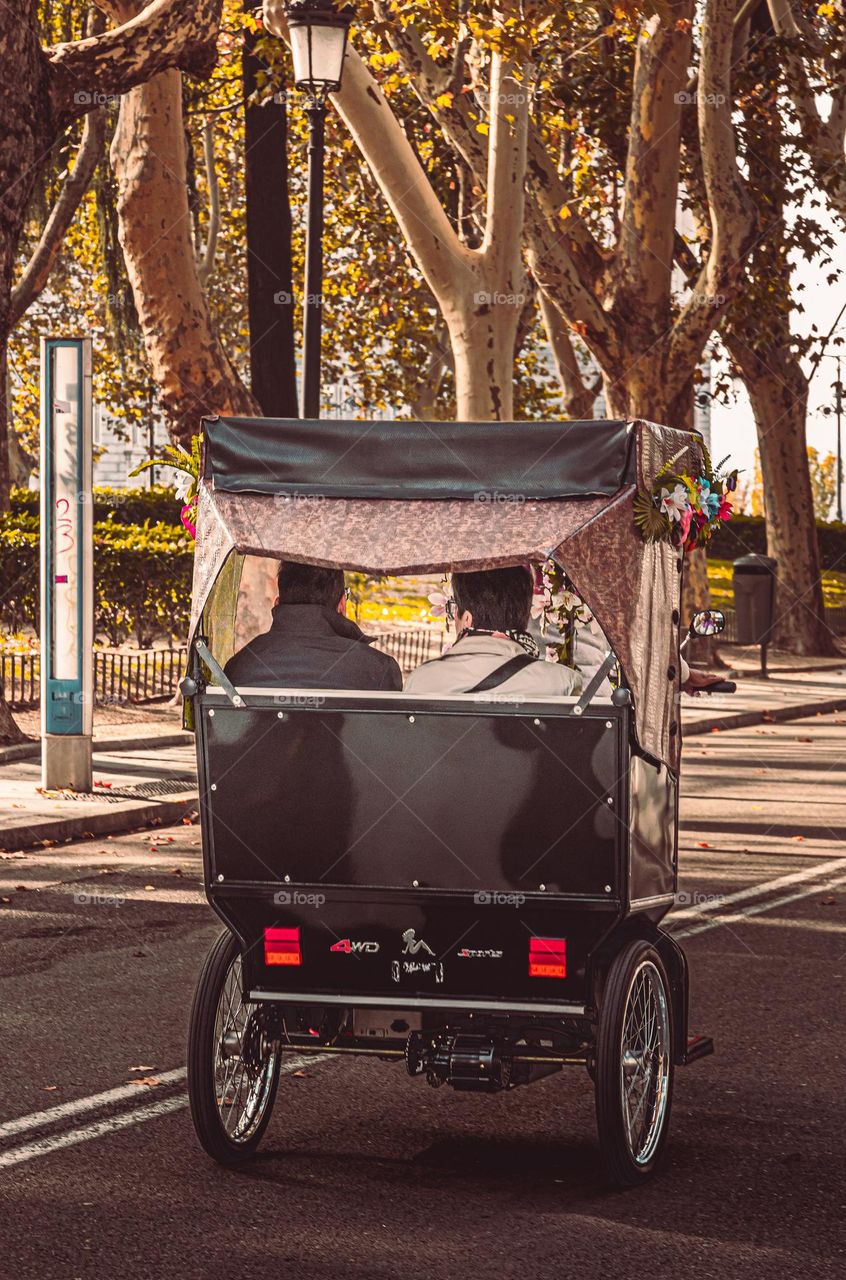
596 940 673 1187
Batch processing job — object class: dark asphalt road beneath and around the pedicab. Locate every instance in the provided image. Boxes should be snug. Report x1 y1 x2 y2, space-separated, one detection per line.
0 716 846 1280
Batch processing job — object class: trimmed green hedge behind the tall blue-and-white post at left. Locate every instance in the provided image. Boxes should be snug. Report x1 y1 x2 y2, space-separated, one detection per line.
0 516 193 648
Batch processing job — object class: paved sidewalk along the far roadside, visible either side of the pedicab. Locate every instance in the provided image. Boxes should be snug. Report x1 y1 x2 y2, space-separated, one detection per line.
0 649 846 852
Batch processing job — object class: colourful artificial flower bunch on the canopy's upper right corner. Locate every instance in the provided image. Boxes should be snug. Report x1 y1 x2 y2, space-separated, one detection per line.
634 444 737 552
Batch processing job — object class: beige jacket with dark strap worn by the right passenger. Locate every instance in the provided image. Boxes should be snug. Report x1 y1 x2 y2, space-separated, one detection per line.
404 636 584 699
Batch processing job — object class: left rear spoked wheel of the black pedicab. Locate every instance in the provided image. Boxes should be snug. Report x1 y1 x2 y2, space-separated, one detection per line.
188 929 280 1165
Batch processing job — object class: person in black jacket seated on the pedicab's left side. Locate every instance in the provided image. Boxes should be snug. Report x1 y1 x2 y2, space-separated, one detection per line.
224 561 402 691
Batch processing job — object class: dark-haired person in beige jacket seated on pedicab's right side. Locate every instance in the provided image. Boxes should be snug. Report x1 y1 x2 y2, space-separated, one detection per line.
406 566 586 699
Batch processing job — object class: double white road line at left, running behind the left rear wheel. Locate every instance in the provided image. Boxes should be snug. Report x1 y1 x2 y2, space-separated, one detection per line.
0 1055 326 1169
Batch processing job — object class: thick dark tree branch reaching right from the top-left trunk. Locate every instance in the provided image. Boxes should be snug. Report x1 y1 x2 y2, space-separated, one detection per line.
45 0 223 128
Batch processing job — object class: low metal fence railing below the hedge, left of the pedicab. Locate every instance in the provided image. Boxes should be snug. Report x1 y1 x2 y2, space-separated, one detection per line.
0 645 187 712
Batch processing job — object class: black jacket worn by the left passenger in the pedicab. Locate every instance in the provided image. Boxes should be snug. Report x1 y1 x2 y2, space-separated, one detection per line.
225 604 402 691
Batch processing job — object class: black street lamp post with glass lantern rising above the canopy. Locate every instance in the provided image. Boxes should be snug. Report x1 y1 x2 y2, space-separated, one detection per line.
280 0 353 419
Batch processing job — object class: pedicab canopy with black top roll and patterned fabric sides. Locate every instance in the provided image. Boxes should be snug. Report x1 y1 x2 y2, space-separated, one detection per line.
191 417 703 767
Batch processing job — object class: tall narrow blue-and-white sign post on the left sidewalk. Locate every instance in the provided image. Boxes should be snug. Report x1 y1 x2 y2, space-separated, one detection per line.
41 338 93 791
